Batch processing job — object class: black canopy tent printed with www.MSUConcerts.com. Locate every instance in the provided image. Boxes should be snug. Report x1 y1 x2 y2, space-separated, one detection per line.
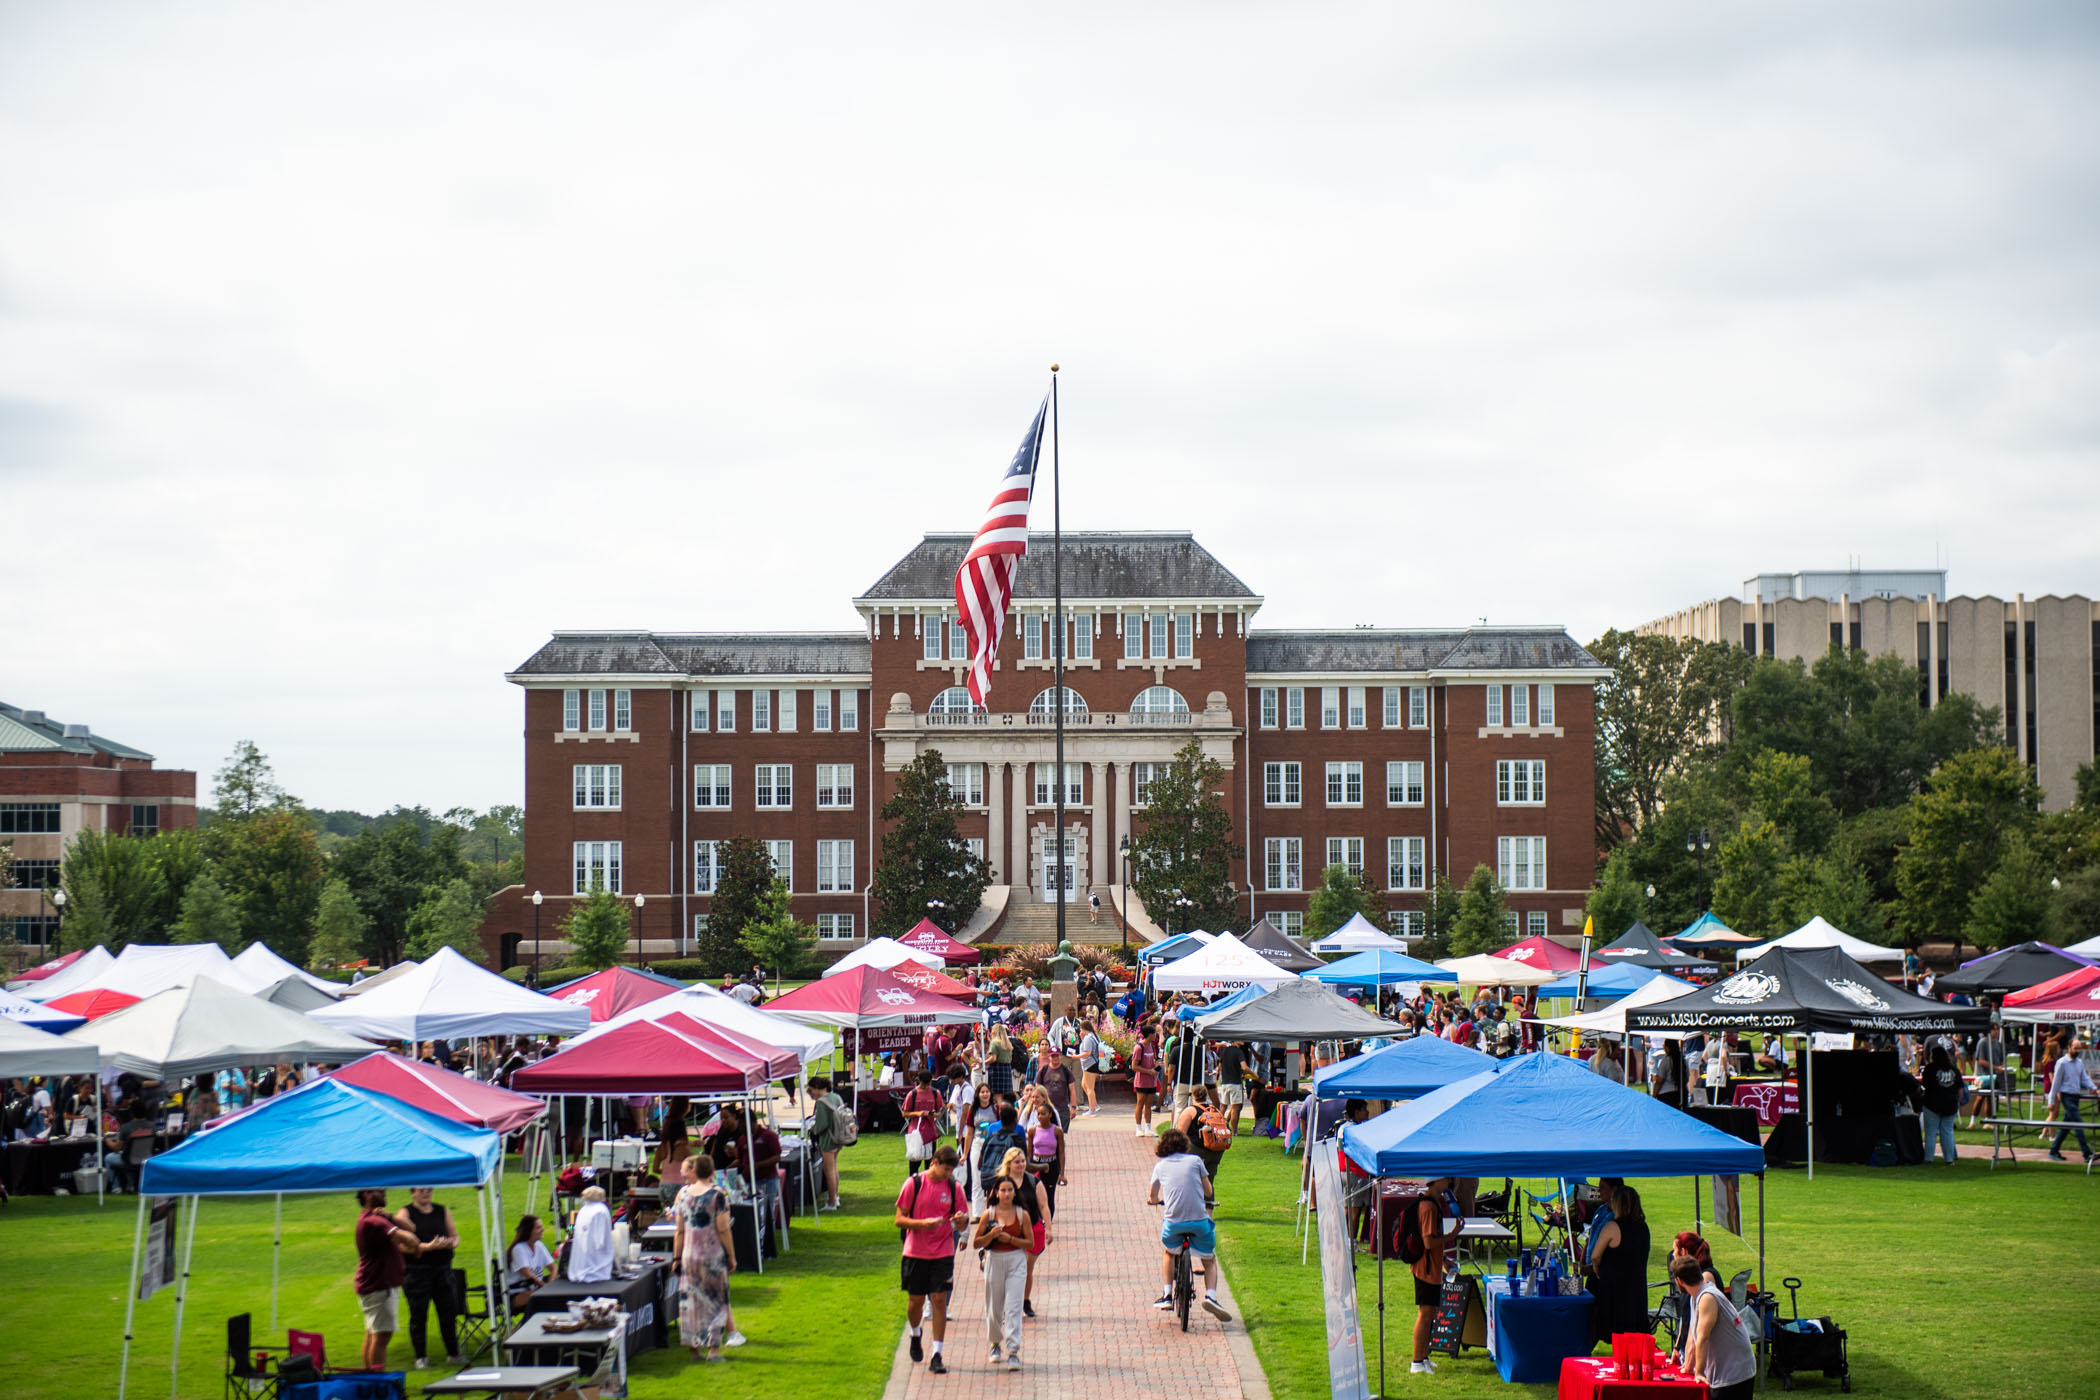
1625 947 1991 1180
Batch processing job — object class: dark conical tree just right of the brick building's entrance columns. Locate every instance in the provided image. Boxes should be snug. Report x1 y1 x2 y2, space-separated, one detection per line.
1130 739 1245 930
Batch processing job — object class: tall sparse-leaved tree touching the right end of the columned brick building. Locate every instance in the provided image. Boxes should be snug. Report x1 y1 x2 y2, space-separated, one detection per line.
1590 630 1749 852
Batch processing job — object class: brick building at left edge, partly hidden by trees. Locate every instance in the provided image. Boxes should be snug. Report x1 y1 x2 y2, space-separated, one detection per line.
0 705 197 947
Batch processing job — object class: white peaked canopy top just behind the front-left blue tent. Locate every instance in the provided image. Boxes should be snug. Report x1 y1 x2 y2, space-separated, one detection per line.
65 978 374 1081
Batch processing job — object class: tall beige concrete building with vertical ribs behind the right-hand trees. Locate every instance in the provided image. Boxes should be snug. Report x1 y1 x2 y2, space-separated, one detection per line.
1638 569 2100 810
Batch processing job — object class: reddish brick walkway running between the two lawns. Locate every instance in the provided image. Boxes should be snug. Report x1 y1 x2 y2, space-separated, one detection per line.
884 1104 1268 1400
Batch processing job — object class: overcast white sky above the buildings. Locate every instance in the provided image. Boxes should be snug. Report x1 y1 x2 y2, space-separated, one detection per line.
0 0 2100 810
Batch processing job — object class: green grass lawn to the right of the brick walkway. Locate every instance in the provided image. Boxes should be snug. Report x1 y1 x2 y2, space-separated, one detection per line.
1218 1136 2100 1400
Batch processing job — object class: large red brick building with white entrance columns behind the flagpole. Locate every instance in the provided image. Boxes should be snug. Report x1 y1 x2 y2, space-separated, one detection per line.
483 533 1602 963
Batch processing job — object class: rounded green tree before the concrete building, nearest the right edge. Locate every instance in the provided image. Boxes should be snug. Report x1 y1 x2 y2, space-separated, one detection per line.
1896 747 2041 940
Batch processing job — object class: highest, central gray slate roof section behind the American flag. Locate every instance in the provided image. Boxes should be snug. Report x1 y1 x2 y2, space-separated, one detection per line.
859 531 1258 602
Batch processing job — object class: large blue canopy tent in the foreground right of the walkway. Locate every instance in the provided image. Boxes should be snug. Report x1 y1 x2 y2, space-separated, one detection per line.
1342 1054 1764 1393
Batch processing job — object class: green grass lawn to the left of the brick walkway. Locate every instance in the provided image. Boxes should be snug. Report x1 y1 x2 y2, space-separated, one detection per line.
0 1138 903 1400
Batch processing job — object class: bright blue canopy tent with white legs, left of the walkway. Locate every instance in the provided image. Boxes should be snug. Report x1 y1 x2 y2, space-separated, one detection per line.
118 1079 502 1400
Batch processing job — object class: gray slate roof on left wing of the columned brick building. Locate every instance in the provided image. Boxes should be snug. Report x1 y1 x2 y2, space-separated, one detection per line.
510 632 869 678
